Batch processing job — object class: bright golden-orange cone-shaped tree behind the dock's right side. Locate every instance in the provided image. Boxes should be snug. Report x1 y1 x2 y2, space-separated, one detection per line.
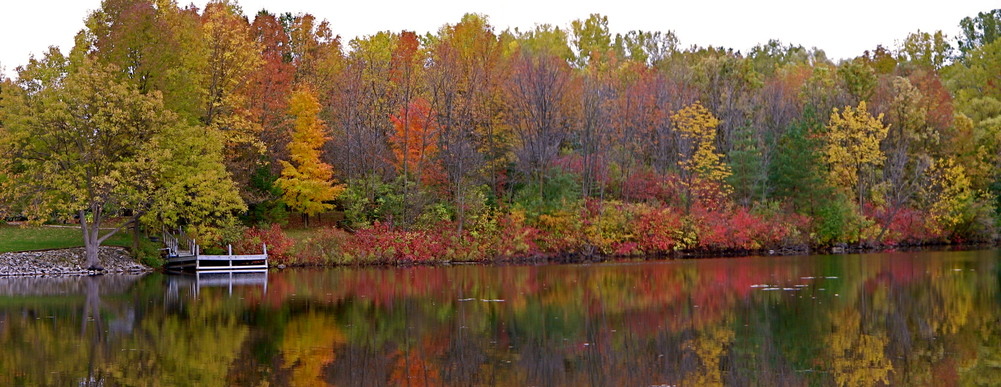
277 85 344 224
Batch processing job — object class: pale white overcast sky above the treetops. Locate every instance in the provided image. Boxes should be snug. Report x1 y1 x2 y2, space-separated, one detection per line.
0 0 1001 76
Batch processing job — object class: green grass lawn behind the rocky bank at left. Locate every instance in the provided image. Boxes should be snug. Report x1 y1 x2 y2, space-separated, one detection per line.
0 225 132 253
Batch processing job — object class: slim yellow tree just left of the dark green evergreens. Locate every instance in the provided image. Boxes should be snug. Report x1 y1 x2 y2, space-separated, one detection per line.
671 102 733 209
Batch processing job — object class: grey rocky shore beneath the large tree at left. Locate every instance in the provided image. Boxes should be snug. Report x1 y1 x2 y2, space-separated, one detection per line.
0 247 152 277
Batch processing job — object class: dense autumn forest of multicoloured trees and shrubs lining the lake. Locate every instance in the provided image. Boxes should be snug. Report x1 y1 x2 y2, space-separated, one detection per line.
0 0 1001 264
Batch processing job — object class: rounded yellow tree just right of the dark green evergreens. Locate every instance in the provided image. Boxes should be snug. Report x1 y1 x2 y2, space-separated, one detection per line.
824 101 889 207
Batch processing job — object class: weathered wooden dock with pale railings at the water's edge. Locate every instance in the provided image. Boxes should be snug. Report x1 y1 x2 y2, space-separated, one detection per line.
163 232 267 273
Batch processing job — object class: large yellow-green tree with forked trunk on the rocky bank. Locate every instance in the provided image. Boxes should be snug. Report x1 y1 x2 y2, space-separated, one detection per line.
0 59 176 269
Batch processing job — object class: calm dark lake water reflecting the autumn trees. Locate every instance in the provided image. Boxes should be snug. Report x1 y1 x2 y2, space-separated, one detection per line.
0 251 1001 386
